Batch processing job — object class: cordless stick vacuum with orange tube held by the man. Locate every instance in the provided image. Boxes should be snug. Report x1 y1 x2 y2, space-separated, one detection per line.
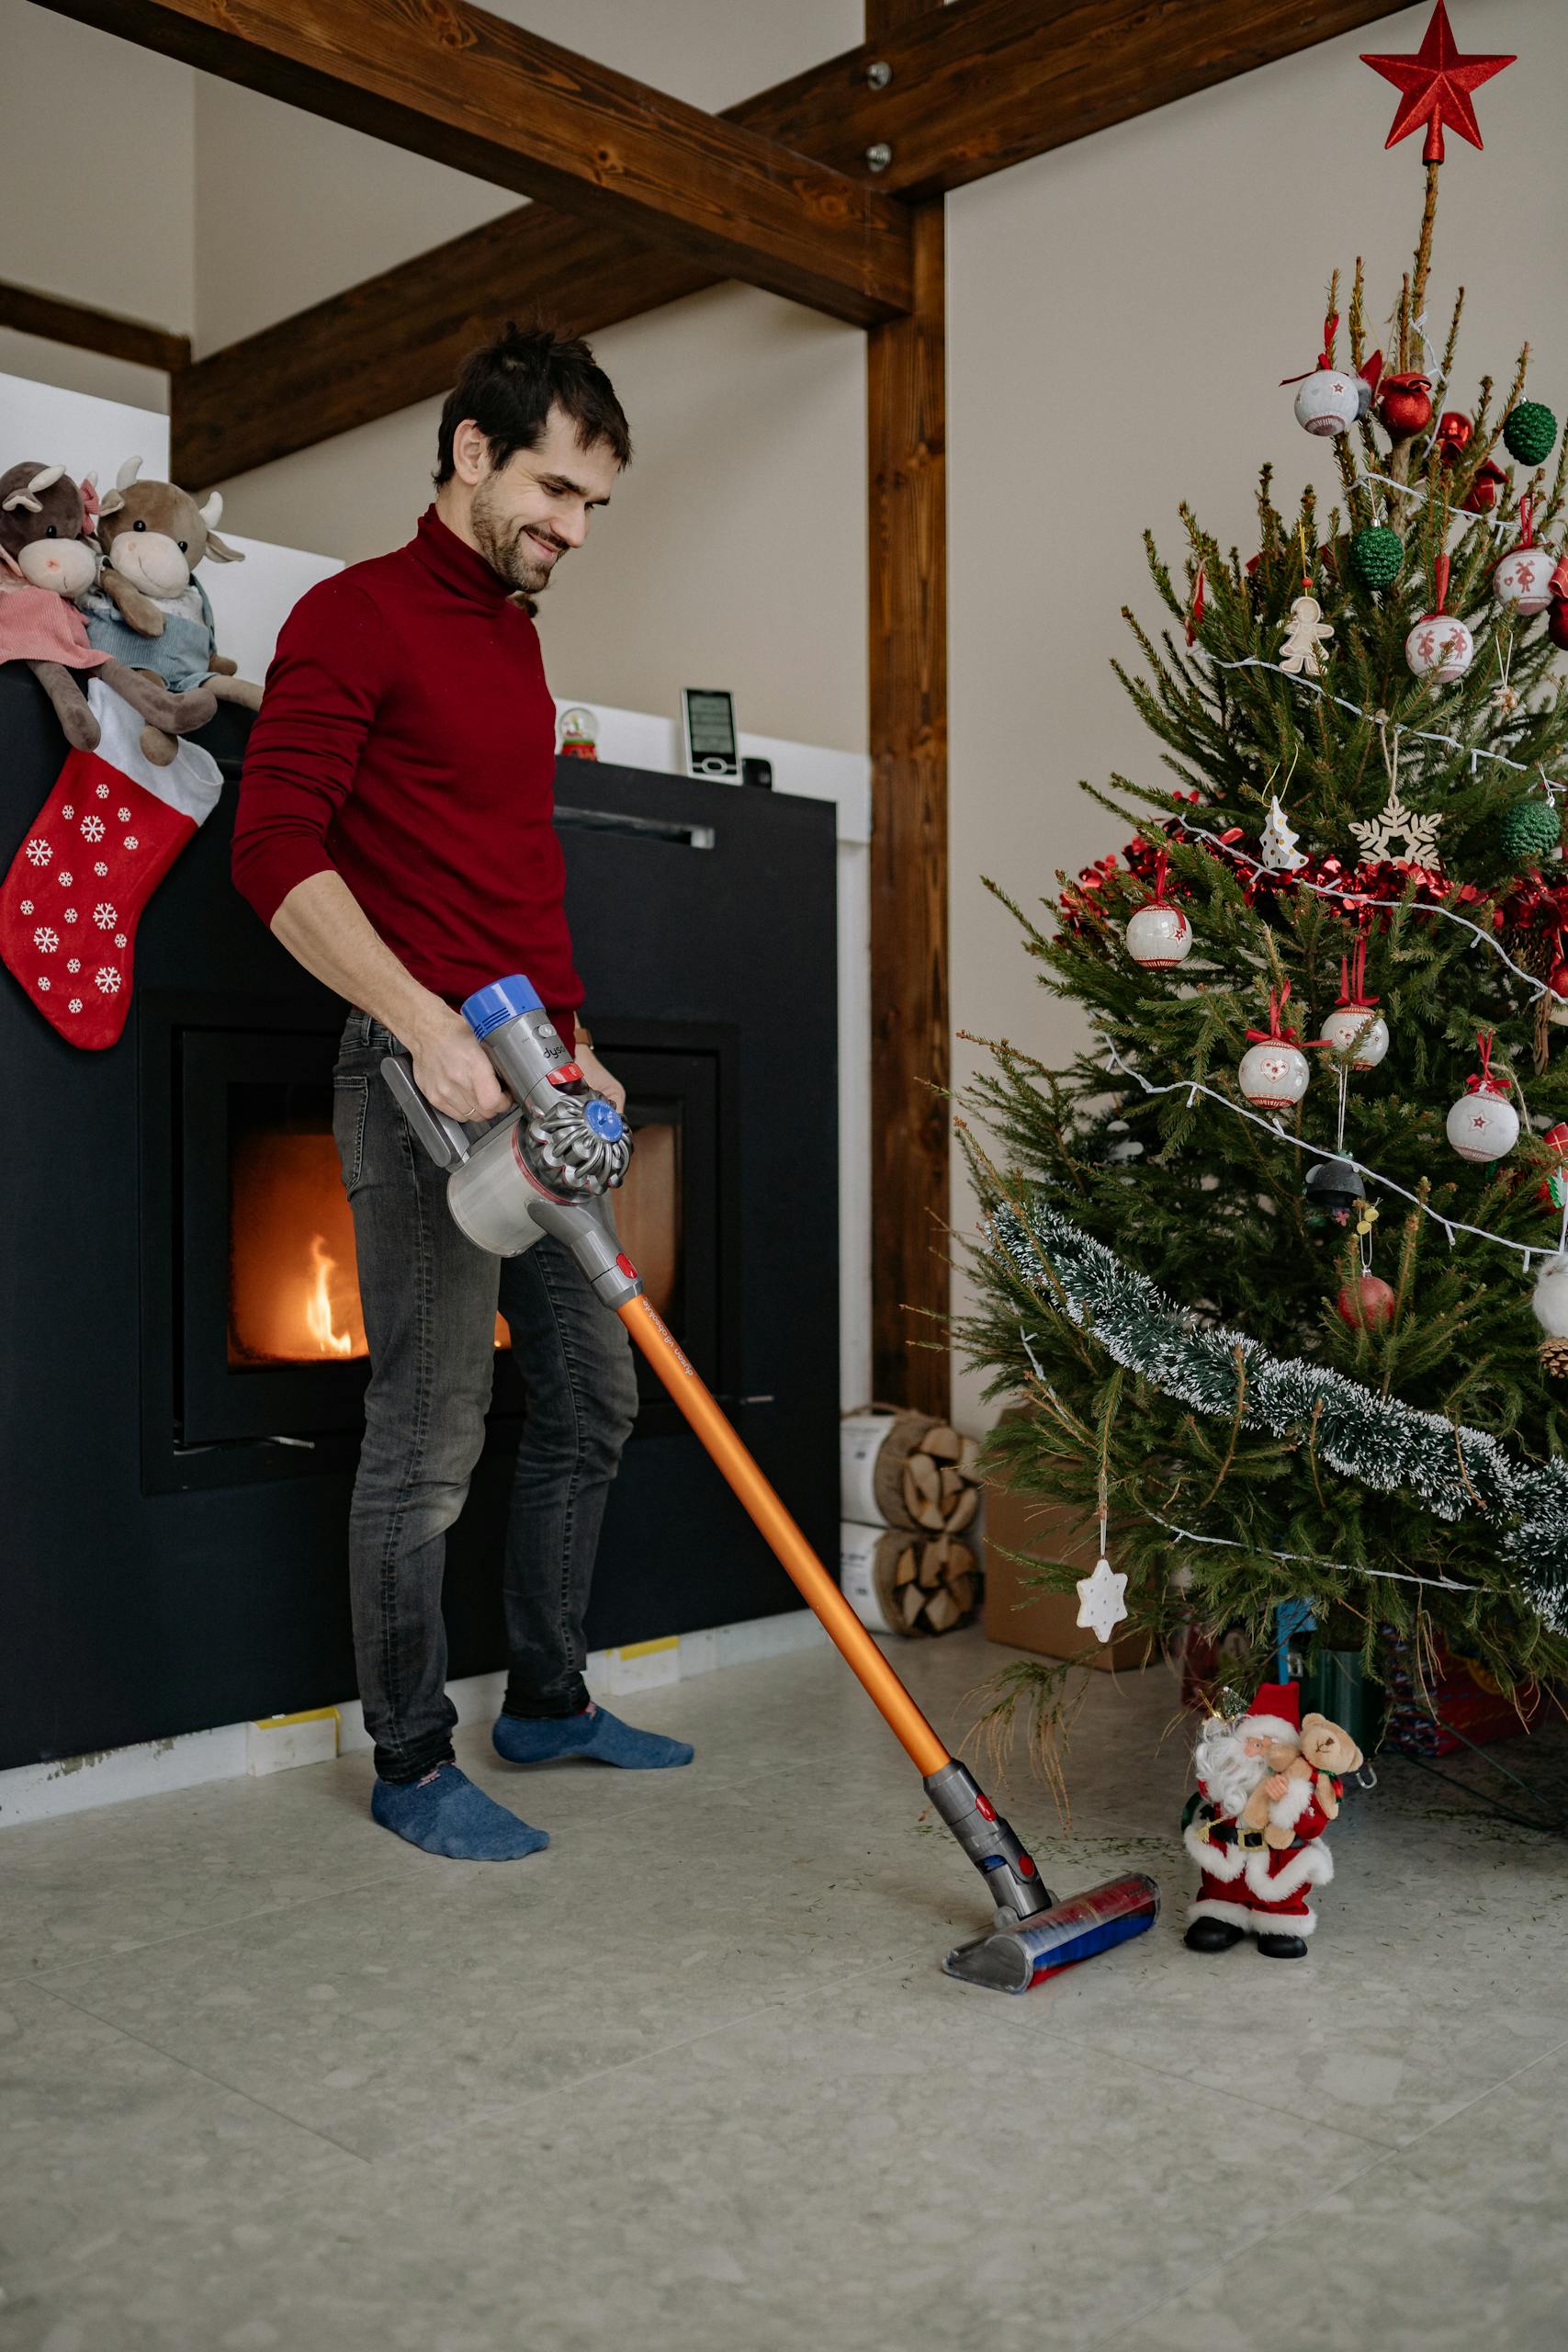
381 976 1159 1992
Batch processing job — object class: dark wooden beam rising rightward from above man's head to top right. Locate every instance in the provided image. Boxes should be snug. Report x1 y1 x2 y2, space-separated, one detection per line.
171 0 1396 484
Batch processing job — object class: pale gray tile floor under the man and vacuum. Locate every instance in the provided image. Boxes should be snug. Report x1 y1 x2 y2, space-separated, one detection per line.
0 1634 1568 2352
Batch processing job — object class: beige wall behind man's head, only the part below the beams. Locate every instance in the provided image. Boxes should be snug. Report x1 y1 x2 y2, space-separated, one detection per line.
223 287 865 751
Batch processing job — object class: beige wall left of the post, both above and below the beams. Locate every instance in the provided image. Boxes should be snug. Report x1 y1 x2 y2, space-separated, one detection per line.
197 0 865 751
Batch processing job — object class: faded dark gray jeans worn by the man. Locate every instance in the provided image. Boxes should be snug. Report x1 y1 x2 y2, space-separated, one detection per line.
333 1013 637 1781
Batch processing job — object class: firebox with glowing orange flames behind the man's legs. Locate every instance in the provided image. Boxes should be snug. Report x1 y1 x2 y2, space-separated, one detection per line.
143 1002 733 1487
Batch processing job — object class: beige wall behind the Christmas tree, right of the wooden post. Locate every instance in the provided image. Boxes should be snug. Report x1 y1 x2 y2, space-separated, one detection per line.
947 0 1568 1425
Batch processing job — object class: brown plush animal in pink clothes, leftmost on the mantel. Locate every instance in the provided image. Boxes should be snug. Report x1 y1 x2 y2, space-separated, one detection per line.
0 458 216 764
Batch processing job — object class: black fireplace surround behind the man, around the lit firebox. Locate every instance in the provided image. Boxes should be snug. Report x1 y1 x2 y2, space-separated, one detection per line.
0 665 840 1769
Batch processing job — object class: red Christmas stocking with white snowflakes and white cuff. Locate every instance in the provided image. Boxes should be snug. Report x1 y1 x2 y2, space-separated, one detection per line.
0 680 223 1049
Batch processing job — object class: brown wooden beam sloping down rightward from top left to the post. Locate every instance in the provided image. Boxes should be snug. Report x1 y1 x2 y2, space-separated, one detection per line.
45 0 909 327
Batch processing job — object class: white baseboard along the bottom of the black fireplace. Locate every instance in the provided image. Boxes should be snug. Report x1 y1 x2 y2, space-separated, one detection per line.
0 1609 828 1830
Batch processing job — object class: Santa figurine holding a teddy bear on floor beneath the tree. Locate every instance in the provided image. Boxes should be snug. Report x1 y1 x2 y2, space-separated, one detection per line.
1182 1681 1333 1959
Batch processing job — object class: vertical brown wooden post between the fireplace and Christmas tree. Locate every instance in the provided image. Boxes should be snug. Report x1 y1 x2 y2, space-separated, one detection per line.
867 198 950 1414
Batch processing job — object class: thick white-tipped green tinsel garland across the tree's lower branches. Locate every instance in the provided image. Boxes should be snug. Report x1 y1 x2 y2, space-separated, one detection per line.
989 1193 1568 1634
